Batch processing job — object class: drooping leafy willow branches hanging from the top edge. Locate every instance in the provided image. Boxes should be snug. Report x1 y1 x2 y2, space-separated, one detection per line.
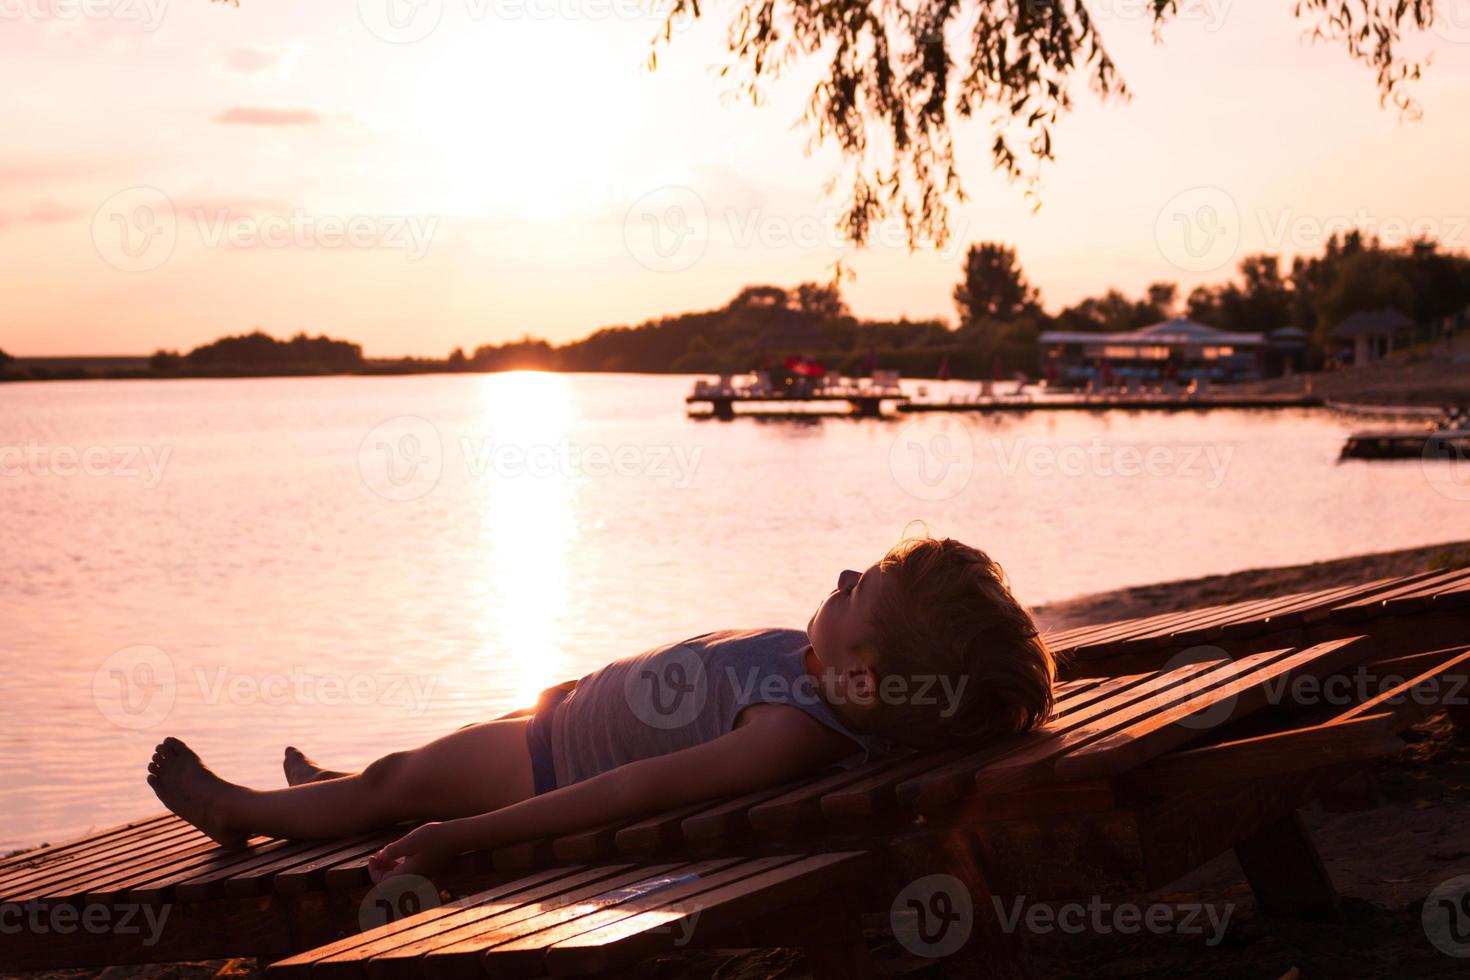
650 0 1435 248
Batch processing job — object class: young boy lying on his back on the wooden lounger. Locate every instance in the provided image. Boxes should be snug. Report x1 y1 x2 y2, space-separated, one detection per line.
148 538 1054 879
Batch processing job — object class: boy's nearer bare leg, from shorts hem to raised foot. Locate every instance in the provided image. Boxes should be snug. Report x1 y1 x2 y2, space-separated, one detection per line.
148 718 534 845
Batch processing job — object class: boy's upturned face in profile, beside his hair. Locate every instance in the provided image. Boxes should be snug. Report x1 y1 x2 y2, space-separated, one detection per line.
807 564 883 717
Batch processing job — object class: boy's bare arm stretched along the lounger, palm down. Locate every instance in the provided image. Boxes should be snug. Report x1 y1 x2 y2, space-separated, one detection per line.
372 705 854 877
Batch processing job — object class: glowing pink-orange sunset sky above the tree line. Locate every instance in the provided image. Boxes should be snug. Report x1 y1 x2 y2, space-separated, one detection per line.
0 0 1470 356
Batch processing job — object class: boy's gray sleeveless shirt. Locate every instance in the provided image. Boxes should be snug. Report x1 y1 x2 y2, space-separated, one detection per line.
551 629 888 786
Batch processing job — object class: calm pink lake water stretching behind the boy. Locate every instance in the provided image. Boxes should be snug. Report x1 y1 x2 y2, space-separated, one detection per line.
0 373 1470 849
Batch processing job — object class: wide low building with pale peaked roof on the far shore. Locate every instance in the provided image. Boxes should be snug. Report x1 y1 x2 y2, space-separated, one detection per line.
1039 317 1267 385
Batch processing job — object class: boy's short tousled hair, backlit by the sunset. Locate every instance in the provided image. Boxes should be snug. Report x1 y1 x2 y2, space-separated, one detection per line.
867 536 1057 746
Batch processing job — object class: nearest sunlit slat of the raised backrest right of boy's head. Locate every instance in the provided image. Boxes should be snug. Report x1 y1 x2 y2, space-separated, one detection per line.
1052 636 1373 786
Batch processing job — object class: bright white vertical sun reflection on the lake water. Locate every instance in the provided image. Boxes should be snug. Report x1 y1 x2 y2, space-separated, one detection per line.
479 372 578 705
